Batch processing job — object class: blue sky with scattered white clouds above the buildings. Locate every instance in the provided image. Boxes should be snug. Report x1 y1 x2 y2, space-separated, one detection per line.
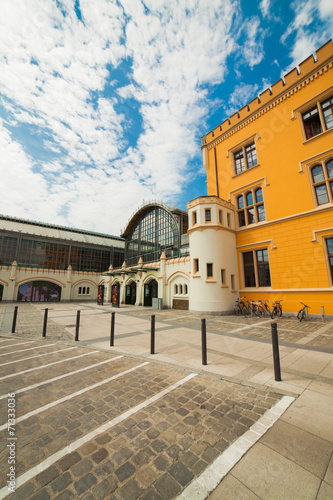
0 0 333 236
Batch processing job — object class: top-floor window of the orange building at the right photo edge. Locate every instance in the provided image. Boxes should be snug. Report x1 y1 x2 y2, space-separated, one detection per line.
302 97 333 139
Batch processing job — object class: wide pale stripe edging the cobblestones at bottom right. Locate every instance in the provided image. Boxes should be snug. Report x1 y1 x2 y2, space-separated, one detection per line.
176 396 295 500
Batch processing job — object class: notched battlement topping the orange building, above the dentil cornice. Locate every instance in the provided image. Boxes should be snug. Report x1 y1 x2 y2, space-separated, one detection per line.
201 39 333 146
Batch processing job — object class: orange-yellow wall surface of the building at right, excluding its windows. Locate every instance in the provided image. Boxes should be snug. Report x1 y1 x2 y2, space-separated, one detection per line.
202 41 333 314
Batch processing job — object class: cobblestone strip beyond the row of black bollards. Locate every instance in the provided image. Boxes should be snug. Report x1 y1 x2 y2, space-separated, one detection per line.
0 303 333 350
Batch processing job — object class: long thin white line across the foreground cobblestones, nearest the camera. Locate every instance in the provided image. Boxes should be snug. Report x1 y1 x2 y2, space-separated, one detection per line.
0 373 197 499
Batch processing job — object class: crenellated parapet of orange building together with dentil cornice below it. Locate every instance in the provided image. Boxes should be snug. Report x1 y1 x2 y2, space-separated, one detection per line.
201 39 333 149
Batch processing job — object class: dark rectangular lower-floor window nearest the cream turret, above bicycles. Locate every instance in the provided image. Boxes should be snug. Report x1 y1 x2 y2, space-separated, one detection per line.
243 248 271 287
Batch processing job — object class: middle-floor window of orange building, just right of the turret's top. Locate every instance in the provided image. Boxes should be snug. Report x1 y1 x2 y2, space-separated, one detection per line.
236 188 266 227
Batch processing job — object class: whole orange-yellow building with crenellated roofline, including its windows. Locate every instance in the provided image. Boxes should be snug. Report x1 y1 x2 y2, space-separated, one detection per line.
202 40 333 315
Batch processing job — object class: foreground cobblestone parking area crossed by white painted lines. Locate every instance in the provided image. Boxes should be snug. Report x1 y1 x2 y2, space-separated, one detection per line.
0 336 281 500
